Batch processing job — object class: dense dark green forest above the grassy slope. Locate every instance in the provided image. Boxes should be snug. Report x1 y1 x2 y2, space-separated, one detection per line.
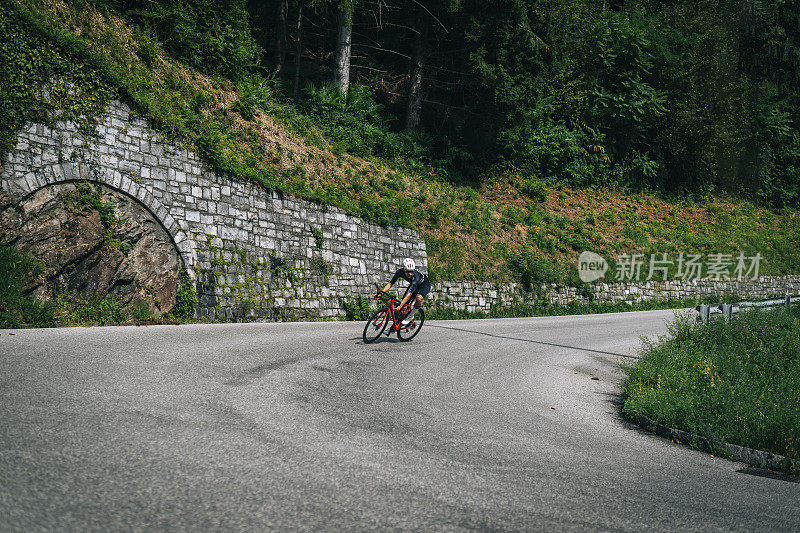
98 0 800 207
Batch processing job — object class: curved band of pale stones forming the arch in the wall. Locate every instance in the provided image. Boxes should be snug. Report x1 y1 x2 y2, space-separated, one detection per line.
2 157 196 266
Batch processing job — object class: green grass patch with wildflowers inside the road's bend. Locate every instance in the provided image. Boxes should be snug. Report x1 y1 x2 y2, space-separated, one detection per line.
623 306 800 468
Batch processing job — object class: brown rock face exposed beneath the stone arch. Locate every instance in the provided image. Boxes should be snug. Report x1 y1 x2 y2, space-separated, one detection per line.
0 183 181 316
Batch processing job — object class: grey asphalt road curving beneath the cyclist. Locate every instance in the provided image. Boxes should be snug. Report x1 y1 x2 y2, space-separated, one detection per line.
0 311 800 532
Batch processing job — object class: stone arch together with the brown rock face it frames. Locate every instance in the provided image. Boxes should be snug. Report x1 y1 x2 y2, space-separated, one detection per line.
0 162 194 316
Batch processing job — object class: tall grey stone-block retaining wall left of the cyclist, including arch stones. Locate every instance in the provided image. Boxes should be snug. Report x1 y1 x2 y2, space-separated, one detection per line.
0 101 427 319
